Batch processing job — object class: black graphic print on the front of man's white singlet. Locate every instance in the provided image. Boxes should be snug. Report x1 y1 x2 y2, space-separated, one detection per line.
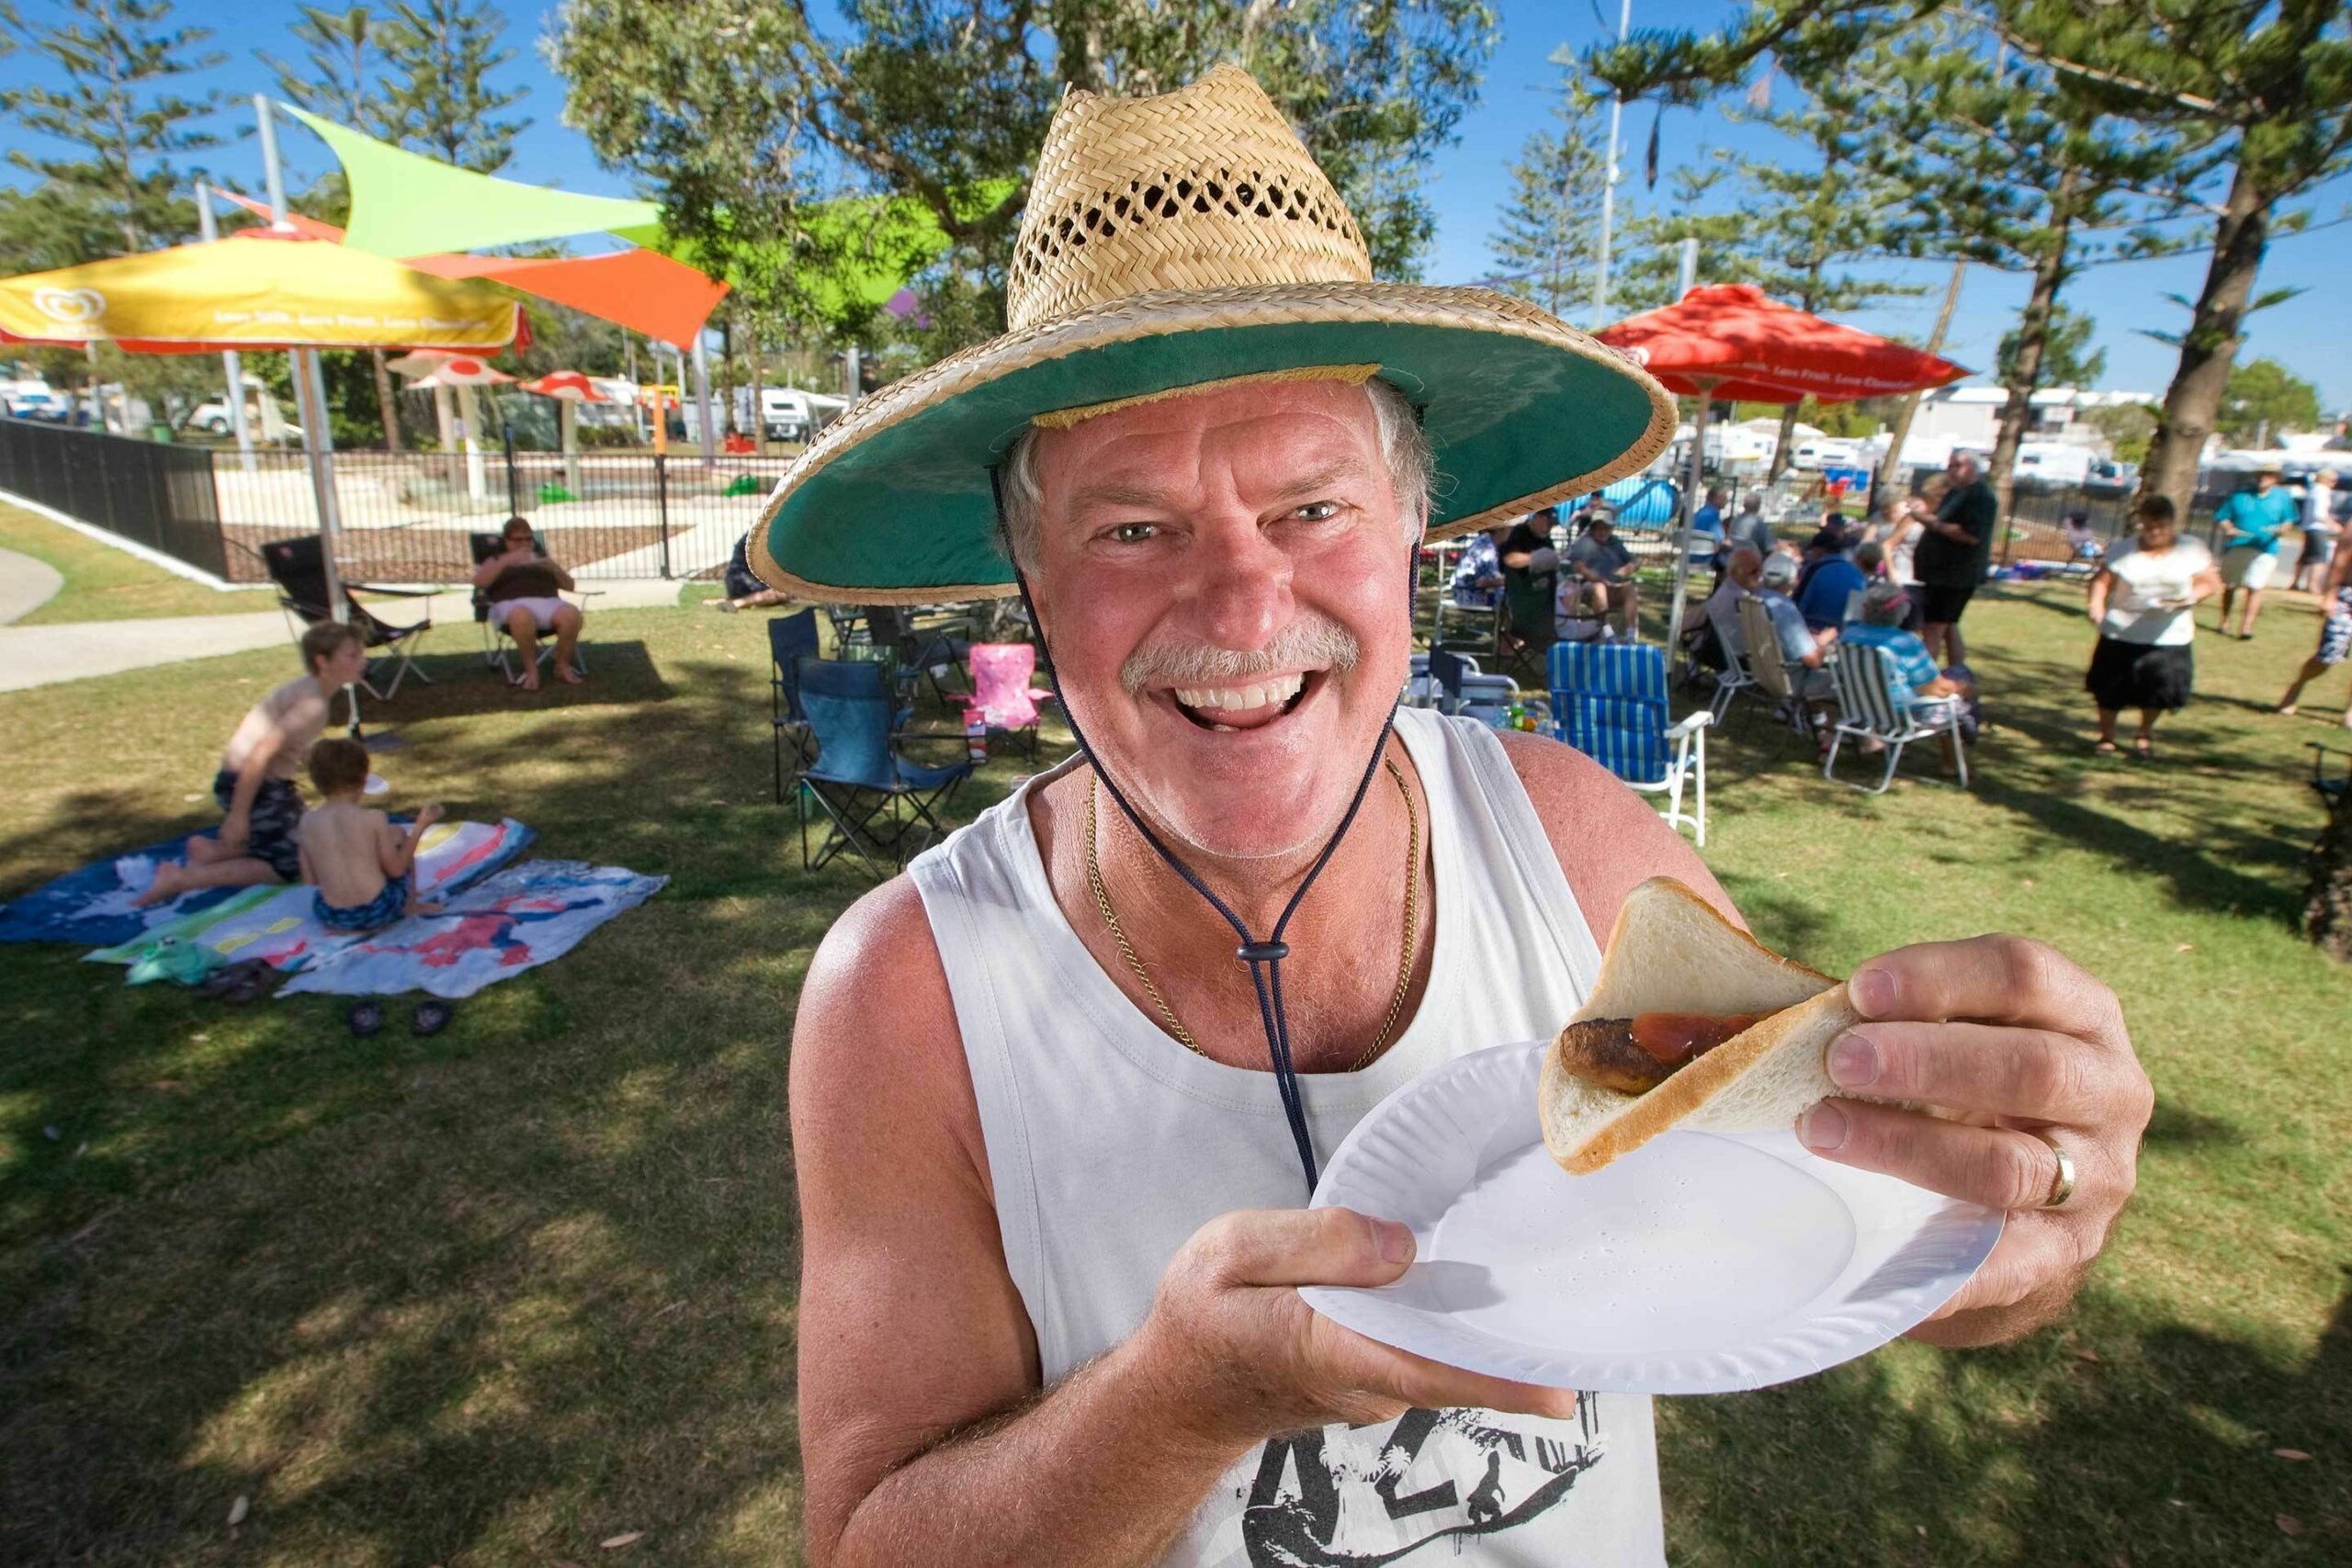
1238 1394 1606 1568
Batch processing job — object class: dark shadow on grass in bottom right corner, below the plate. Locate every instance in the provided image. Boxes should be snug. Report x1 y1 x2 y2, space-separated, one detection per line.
1660 1288 2352 1568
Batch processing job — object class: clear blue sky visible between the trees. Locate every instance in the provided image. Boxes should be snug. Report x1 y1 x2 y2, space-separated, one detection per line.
0 0 2352 409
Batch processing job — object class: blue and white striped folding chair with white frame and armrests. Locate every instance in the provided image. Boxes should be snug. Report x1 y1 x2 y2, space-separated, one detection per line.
1550 642 1714 849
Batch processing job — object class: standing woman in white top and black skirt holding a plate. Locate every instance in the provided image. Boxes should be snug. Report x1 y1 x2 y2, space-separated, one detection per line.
2084 496 2221 757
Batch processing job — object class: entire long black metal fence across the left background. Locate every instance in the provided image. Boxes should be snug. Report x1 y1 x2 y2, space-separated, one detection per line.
0 419 795 583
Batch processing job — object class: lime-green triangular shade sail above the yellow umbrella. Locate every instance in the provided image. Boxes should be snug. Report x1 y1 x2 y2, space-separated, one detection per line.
280 104 661 256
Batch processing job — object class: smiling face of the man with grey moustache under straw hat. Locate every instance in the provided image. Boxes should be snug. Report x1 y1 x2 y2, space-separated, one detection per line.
1030 381 1411 858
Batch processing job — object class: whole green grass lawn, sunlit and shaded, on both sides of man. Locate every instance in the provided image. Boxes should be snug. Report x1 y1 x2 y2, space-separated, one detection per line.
0 588 2352 1568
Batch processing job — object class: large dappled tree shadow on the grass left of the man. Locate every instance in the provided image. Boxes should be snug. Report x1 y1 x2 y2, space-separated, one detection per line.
0 644 1066 1565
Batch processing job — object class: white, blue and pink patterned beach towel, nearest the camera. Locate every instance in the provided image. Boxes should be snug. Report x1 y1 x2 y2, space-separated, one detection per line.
277 861 671 997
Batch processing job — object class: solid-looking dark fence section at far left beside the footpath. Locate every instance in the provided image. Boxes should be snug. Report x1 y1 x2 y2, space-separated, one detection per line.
0 419 232 576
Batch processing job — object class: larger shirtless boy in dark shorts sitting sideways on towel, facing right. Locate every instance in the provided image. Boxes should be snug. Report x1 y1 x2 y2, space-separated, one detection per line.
131 621 367 908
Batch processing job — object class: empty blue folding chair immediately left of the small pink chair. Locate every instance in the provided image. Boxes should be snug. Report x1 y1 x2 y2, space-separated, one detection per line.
799 659 971 877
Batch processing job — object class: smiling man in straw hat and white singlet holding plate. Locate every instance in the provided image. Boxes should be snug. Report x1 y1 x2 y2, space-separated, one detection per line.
771 66 2150 1563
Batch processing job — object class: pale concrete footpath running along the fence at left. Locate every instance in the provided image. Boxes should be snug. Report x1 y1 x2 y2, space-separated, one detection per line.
0 581 680 691
